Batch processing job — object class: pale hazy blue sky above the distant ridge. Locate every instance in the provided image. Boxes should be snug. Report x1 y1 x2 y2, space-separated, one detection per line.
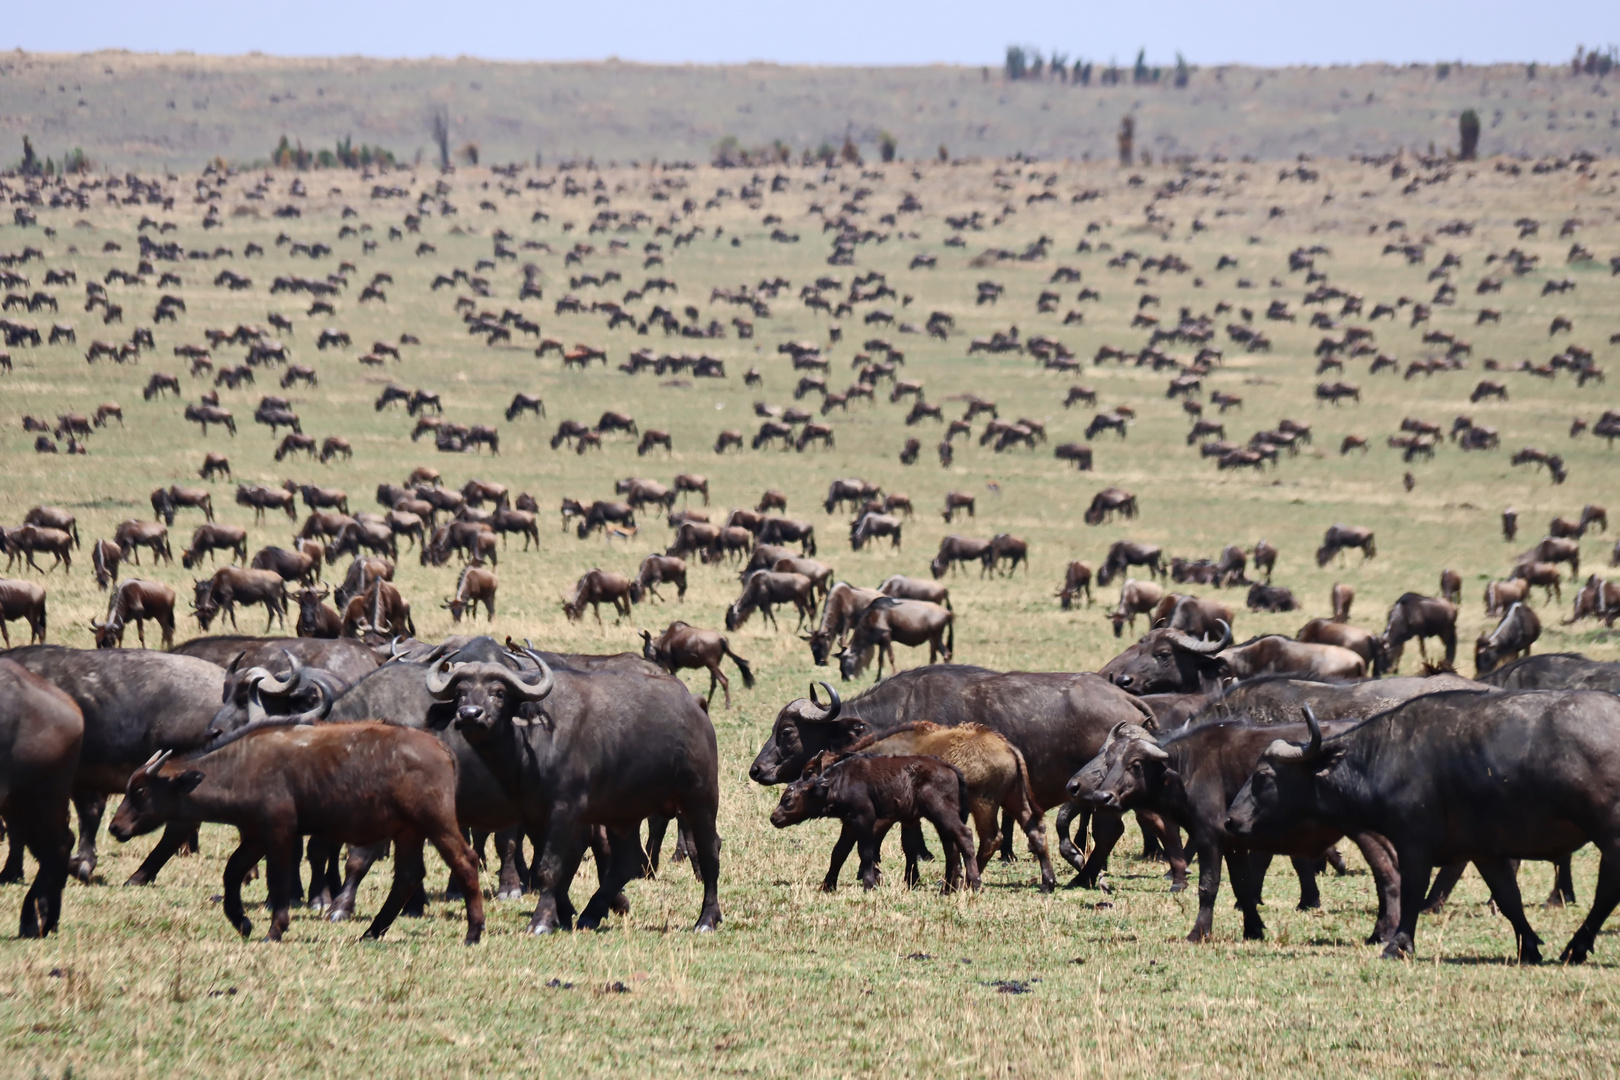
0 0 1620 65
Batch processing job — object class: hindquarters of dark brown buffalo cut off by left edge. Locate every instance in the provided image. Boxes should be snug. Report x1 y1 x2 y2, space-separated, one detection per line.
0 661 84 938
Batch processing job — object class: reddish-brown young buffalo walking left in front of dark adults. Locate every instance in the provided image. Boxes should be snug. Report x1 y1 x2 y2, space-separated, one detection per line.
110 721 484 944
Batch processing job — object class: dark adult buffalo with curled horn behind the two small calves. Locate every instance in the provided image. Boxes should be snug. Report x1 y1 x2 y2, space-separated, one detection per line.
748 664 1152 887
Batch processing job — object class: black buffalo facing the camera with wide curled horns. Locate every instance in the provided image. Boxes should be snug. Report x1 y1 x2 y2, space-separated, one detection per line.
424 649 721 933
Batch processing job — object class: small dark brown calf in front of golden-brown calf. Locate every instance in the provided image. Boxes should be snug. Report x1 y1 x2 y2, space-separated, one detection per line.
771 753 978 892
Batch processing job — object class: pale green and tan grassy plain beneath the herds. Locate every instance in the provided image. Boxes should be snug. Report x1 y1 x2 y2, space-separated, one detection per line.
0 141 1620 1077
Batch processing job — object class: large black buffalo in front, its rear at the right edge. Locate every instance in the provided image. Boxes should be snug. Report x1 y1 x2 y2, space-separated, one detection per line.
1226 691 1620 963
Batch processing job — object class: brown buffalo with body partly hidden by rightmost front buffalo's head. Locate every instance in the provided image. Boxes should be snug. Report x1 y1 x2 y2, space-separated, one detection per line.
1069 717 1398 941
